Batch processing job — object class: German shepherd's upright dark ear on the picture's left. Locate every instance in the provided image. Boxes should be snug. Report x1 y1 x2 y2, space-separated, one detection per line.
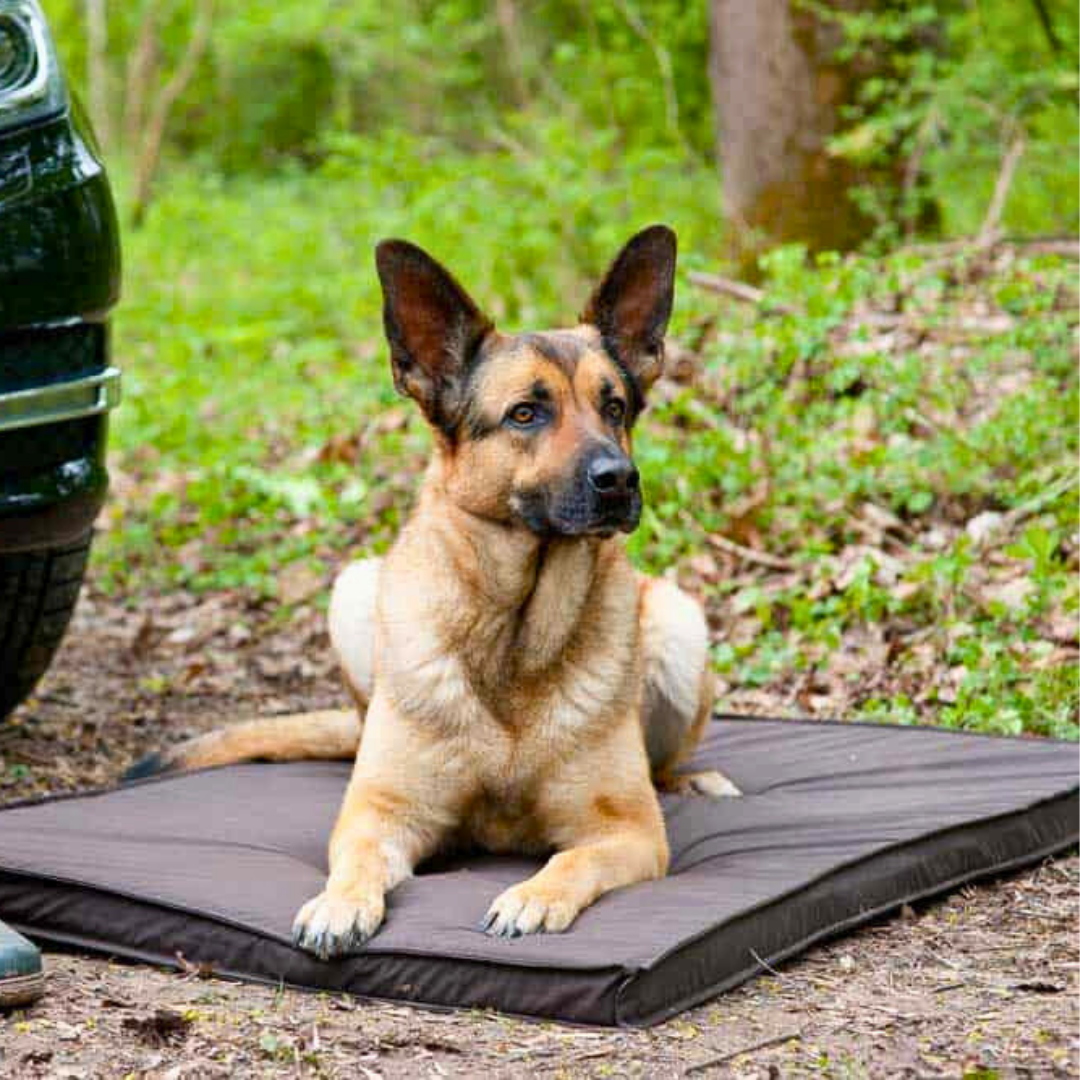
375 240 492 434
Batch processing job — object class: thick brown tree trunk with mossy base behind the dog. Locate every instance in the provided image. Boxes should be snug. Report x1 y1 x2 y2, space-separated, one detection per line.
708 0 872 269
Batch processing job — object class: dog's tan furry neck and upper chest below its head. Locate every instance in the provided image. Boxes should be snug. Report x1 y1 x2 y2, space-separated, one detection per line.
377 531 639 768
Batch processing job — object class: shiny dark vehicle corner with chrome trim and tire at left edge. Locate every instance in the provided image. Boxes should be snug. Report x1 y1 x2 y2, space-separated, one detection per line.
0 6 120 718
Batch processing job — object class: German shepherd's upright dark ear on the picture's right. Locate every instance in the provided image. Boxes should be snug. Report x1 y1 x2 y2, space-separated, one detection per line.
581 225 676 406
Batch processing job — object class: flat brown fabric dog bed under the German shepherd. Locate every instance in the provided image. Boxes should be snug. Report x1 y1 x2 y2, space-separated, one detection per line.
0 717 1078 1025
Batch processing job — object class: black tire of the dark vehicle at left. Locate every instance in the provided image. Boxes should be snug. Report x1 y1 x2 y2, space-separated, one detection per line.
0 532 91 719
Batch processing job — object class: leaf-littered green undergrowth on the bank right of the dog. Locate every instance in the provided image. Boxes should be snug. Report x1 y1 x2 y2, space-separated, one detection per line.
631 249 1078 738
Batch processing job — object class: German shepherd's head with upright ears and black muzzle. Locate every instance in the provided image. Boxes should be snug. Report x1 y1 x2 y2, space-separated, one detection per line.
376 226 675 536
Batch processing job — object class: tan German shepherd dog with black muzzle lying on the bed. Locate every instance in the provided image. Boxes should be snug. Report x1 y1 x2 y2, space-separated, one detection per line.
126 226 739 958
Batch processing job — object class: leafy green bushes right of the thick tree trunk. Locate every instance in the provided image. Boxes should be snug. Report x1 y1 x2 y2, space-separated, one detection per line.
808 0 1080 241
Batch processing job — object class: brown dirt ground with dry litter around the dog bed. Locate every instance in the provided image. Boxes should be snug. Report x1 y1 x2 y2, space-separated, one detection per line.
0 582 1080 1080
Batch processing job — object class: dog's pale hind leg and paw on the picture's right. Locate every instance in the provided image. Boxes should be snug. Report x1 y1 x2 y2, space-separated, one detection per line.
639 576 741 798
